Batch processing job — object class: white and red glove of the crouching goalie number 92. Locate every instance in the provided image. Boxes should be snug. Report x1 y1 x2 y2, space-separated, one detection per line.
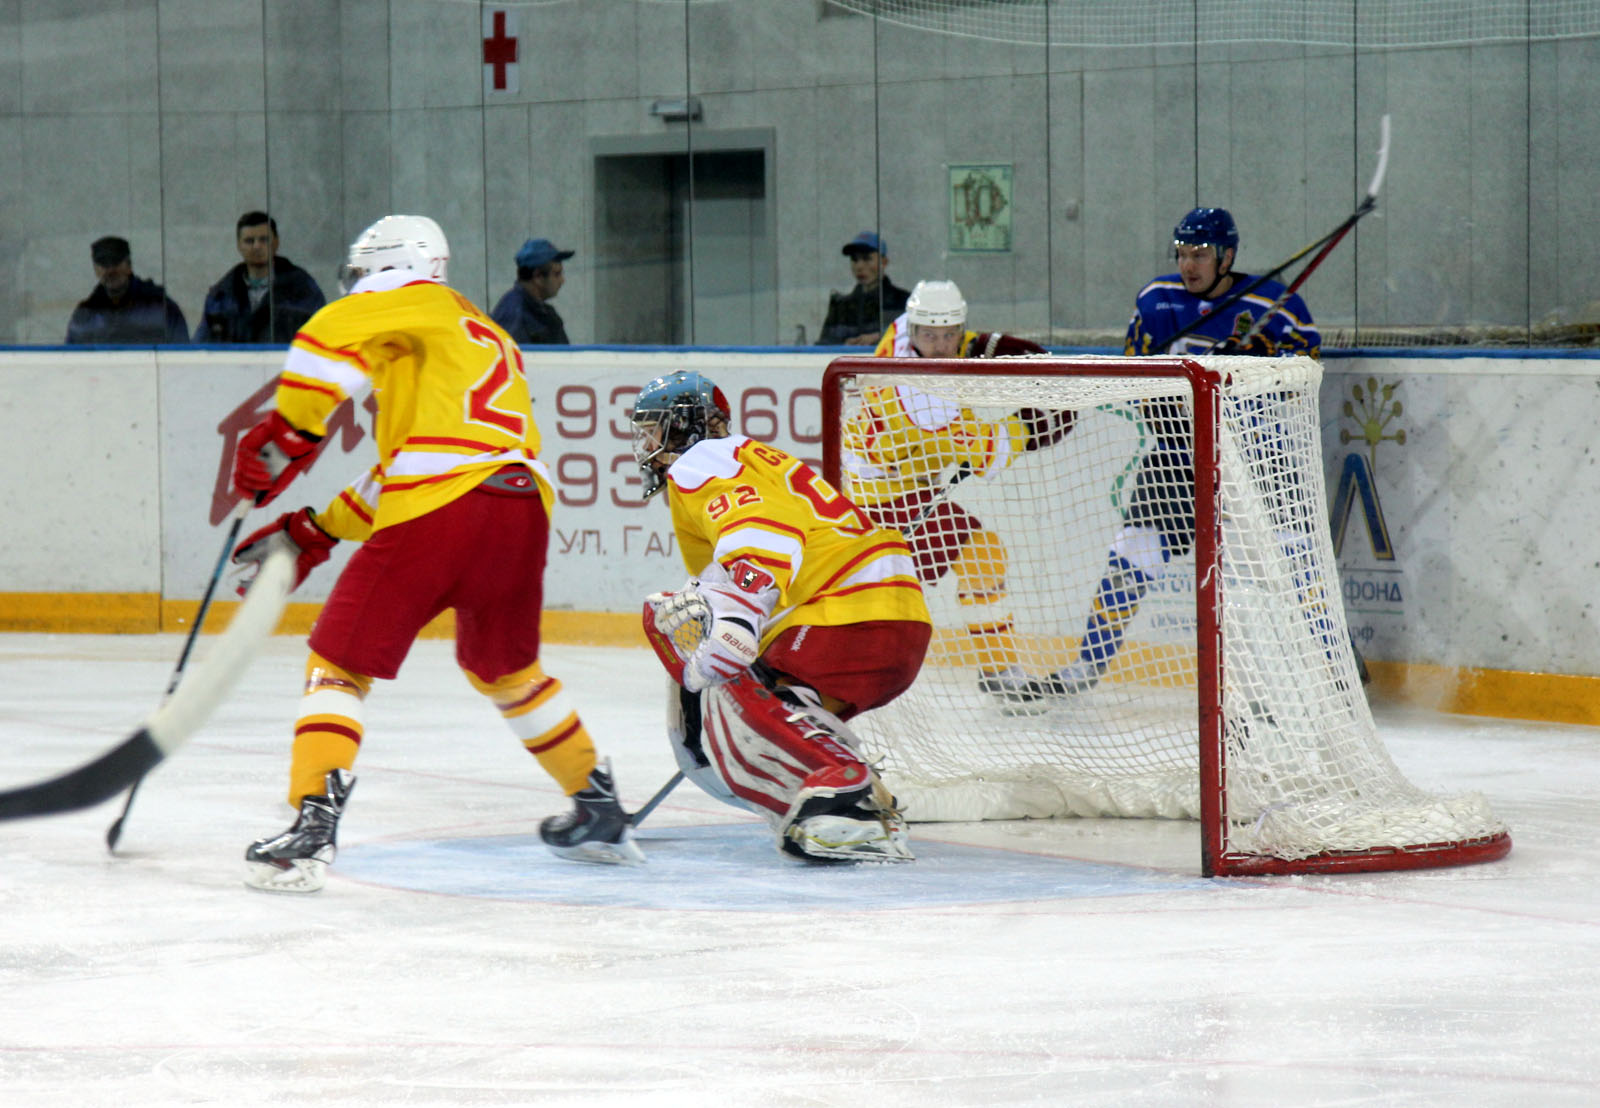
645 560 778 692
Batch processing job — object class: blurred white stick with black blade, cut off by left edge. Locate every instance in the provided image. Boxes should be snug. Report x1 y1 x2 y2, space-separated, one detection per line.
0 531 294 820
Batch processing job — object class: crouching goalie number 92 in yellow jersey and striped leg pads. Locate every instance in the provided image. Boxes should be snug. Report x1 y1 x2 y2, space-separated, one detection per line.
632 373 931 861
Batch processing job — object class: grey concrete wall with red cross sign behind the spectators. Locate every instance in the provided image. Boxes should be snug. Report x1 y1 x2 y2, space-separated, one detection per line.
0 0 1600 344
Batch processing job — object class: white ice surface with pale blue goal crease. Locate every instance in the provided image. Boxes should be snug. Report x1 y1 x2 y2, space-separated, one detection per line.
0 634 1600 1108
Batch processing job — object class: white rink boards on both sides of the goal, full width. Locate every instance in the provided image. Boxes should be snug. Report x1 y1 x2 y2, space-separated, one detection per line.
0 347 1600 674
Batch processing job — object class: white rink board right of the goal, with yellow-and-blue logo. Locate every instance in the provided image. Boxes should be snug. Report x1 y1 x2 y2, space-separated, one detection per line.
1322 357 1600 674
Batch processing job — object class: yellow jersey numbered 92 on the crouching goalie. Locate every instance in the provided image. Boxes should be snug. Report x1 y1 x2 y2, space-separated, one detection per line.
667 436 931 650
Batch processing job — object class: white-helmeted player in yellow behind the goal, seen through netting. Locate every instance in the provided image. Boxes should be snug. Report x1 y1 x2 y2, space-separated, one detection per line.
842 280 1072 698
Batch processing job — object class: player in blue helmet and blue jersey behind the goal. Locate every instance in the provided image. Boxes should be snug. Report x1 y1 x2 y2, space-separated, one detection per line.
1011 208 1350 700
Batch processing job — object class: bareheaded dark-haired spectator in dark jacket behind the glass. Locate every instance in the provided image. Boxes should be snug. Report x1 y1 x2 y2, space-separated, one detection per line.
195 211 326 343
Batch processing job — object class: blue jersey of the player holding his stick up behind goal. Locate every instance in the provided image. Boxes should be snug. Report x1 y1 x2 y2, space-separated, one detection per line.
1123 274 1322 357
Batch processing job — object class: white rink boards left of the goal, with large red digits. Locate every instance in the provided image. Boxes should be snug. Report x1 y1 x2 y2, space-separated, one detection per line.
0 349 830 612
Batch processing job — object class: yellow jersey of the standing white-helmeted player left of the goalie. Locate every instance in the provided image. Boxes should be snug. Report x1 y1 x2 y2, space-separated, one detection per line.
277 269 554 540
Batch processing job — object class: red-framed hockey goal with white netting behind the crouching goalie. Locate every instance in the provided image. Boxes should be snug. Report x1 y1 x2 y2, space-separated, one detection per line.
822 357 1510 874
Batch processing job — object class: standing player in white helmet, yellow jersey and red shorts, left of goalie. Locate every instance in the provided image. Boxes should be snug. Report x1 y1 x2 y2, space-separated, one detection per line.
234 216 643 892
